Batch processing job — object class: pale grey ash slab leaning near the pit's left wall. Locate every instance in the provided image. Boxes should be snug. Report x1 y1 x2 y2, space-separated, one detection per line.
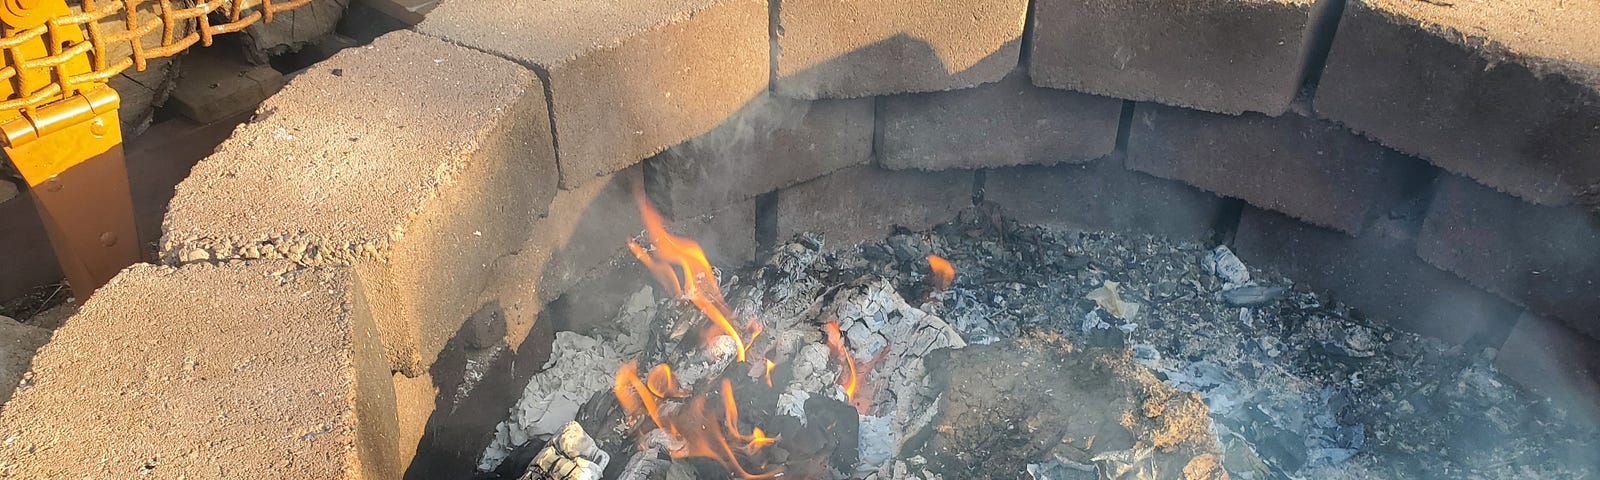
478 331 622 472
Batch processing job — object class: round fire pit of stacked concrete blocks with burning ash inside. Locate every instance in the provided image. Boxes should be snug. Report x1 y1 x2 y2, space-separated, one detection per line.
0 0 1600 480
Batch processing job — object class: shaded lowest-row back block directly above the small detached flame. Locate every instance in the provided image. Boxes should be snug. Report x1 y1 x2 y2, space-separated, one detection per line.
778 165 976 248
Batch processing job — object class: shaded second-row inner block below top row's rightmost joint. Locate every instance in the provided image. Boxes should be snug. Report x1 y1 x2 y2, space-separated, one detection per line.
1128 104 1426 235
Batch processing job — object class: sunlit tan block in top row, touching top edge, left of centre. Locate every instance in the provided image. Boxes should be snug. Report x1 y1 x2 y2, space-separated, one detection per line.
416 0 771 189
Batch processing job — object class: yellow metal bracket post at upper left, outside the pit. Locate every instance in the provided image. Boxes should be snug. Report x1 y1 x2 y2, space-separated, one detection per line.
0 0 141 296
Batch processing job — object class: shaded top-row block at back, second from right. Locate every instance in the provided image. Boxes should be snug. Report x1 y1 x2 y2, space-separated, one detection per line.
1029 0 1331 115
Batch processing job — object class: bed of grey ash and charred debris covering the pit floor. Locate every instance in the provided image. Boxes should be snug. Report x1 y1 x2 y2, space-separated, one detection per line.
480 211 1600 480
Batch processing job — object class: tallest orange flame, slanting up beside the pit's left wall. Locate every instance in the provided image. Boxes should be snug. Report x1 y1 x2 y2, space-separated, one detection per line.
627 186 762 362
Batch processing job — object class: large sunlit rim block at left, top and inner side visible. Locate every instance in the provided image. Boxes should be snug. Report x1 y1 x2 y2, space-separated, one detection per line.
162 32 557 376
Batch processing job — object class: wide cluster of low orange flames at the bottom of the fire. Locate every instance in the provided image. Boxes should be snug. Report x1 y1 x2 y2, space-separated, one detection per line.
613 362 778 478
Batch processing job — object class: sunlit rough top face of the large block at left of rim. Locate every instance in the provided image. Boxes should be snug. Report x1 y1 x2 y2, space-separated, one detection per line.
163 30 544 254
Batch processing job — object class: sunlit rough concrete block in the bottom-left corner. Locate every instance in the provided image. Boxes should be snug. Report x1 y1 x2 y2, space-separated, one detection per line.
0 261 400 478
